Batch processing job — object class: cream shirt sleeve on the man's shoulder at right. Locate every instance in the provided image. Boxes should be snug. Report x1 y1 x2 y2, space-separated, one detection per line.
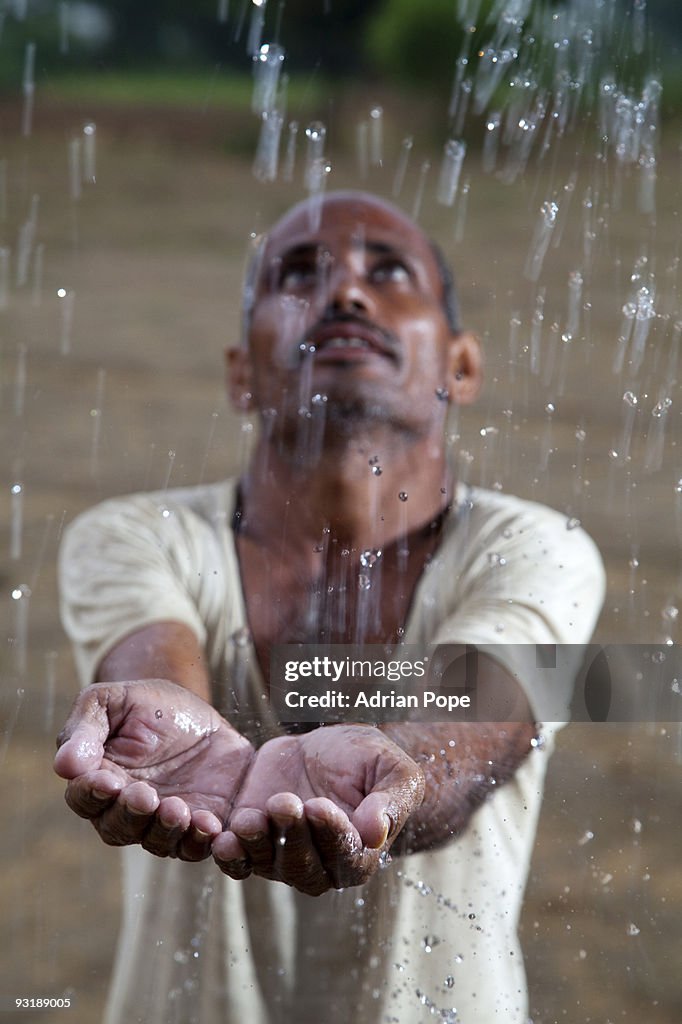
435 503 605 724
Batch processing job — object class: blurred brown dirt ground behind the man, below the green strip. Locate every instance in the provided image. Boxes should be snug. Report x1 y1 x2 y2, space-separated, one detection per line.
0 90 682 1024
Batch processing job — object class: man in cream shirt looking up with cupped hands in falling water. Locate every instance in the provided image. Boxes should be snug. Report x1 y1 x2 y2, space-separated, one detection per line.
55 193 603 1024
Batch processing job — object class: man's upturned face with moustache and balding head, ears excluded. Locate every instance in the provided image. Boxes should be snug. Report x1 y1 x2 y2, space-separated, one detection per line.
228 194 477 434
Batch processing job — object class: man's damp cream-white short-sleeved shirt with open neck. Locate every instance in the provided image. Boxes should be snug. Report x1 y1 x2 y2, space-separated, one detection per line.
60 480 604 1024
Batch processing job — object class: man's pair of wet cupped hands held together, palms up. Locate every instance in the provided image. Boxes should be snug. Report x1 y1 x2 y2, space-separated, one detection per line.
55 680 423 895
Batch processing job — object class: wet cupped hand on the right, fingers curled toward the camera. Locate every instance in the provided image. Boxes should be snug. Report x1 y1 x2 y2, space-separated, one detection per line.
213 725 424 896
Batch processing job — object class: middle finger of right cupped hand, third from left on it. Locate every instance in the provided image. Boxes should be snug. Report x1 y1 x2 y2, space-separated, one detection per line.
265 793 332 896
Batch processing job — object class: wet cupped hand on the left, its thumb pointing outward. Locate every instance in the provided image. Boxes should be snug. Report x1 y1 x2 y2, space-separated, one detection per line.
54 679 254 860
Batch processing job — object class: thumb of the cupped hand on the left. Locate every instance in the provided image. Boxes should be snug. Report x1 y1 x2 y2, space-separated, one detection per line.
54 686 111 778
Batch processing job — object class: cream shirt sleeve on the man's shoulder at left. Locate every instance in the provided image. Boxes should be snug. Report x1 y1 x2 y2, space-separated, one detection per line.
59 495 208 686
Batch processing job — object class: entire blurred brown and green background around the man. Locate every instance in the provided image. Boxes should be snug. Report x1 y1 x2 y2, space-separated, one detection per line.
0 0 682 1024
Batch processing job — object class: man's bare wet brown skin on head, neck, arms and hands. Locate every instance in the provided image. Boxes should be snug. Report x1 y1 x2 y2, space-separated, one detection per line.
56 194 534 895
